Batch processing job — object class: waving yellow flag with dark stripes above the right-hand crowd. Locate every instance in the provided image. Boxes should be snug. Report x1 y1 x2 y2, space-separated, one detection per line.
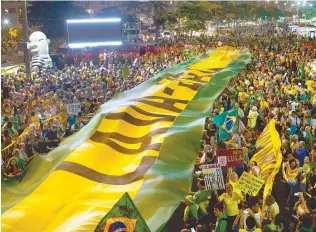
251 119 282 205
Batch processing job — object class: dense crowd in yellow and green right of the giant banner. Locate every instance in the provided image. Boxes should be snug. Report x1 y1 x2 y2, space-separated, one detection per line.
183 33 316 232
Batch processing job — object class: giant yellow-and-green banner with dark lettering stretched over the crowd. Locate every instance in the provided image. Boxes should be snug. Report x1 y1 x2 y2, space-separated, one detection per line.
1 47 251 232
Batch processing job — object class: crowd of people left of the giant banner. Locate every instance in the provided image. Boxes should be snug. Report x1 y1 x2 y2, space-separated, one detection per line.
1 41 210 179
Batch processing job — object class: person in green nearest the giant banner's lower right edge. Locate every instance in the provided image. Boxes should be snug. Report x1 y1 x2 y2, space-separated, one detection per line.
183 195 199 228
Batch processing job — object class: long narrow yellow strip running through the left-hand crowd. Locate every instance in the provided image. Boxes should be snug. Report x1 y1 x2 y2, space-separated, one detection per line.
1 112 67 162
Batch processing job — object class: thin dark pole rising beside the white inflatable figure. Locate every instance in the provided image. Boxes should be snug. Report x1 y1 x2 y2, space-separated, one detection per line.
21 0 31 78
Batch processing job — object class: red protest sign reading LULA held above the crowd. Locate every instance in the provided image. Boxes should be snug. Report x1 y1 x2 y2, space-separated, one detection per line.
216 149 243 167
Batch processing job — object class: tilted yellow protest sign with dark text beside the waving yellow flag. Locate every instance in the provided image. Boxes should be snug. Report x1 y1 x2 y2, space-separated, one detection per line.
236 172 264 196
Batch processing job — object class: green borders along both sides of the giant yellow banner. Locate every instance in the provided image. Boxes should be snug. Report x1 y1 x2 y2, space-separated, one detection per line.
1 49 251 231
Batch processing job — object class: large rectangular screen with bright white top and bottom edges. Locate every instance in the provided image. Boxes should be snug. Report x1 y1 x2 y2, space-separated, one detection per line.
66 17 122 48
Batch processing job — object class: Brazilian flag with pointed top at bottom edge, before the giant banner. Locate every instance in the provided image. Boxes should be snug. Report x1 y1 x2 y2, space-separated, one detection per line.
95 193 150 232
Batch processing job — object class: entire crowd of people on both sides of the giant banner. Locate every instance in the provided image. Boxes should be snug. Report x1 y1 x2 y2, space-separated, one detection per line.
1 27 316 232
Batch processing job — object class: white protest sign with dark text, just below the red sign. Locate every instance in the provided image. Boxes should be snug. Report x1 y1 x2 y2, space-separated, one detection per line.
202 164 225 191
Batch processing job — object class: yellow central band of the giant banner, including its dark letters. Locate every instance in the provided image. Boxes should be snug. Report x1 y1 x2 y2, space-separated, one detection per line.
1 47 238 232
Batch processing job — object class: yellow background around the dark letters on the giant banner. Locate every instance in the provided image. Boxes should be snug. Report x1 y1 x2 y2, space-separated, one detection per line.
1 47 238 232
